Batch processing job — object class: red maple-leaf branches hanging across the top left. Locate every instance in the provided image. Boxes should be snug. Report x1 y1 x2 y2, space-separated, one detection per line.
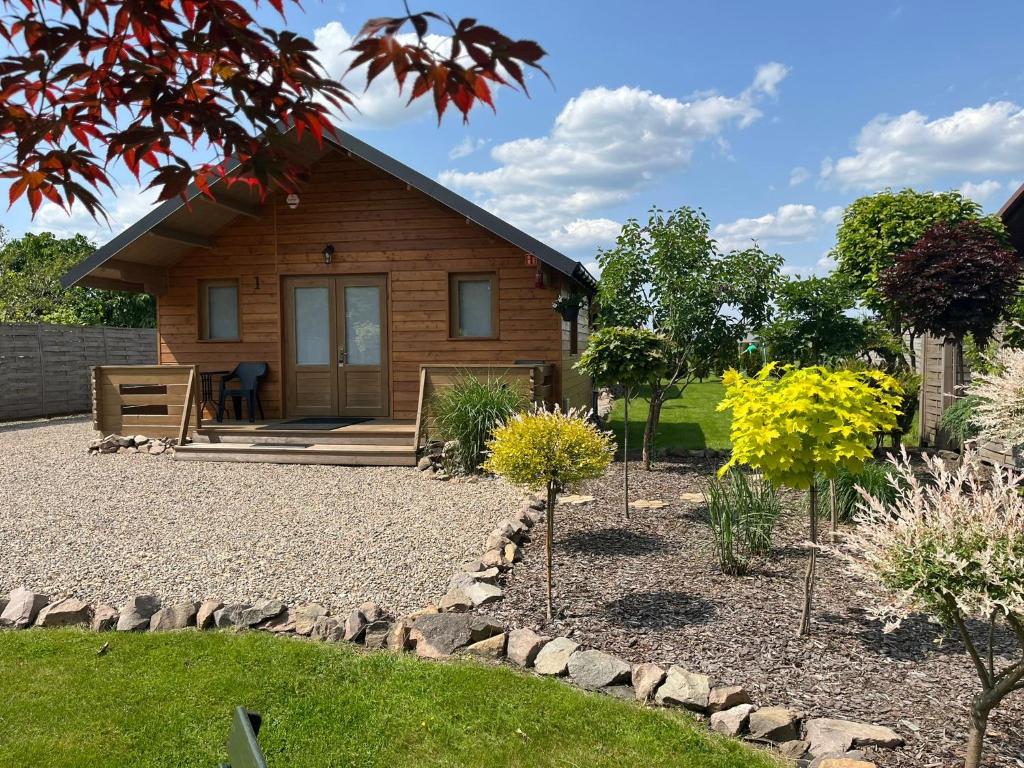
0 0 546 216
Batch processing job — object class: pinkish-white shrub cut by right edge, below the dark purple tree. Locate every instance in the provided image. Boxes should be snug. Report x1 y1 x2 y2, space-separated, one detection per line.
968 347 1024 447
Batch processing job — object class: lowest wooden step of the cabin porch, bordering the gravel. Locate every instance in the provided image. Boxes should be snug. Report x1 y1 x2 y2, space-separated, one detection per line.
174 441 416 467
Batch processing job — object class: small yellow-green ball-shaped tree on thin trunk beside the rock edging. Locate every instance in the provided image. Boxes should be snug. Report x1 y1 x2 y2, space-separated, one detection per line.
483 408 615 621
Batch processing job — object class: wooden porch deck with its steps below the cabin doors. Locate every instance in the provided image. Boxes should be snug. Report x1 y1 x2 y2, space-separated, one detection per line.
174 419 416 467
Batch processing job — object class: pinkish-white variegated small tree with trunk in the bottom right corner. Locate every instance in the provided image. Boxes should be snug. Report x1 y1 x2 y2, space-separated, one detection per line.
850 449 1024 768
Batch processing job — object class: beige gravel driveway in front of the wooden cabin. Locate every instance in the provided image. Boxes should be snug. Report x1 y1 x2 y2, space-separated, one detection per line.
0 419 521 611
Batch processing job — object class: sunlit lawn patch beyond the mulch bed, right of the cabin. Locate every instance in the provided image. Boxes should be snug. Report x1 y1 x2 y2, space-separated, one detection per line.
610 379 731 456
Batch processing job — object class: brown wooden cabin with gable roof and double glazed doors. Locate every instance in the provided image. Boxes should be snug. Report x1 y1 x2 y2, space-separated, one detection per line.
63 131 595 463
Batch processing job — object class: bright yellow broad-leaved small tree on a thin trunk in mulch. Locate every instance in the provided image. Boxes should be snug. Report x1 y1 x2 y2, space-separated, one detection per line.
718 364 901 635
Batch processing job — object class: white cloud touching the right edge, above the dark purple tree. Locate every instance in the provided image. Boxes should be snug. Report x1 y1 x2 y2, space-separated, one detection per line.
821 101 1024 189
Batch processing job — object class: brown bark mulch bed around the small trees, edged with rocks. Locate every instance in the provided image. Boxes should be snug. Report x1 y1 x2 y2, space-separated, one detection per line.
487 460 1024 768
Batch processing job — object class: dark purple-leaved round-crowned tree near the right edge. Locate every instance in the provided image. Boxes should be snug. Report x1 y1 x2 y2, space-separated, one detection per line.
879 221 1022 391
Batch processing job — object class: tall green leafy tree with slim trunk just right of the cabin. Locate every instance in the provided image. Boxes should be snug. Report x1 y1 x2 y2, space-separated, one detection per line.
597 207 782 469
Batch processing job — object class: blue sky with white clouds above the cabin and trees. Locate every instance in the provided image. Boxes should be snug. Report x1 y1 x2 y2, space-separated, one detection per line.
3 0 1024 273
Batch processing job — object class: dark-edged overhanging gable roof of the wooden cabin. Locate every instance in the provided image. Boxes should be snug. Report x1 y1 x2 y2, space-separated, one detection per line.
61 129 597 293
